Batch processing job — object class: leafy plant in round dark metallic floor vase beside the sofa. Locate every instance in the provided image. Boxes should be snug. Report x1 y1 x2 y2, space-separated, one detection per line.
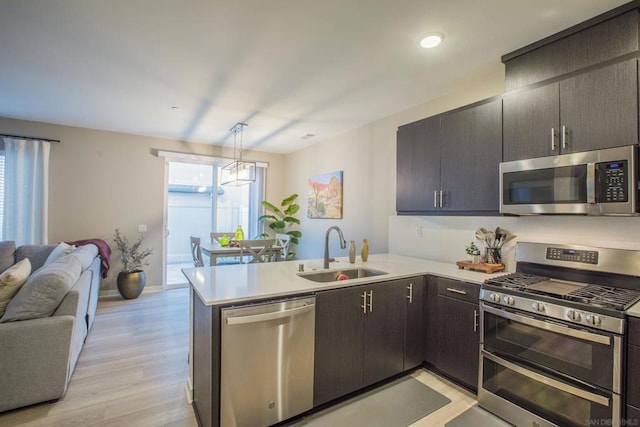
113 228 153 299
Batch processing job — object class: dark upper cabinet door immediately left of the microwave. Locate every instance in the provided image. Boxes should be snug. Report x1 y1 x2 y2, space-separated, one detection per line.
440 100 502 213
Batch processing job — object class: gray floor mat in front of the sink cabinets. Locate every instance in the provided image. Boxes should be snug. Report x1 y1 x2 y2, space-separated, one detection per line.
292 377 451 427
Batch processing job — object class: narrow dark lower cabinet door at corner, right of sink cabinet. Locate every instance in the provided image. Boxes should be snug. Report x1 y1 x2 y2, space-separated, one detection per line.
403 277 427 371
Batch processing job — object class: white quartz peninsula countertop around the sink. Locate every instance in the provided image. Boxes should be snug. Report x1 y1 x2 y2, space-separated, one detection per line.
182 254 505 305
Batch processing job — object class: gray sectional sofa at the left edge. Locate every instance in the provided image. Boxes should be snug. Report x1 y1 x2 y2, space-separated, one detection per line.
0 242 101 412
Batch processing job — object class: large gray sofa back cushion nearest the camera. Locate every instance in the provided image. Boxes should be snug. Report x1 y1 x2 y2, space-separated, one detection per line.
0 255 82 323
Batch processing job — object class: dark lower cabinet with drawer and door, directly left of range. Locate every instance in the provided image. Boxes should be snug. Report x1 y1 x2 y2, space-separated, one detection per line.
435 278 480 390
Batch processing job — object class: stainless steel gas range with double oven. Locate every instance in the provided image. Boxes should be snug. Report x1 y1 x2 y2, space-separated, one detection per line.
478 242 640 427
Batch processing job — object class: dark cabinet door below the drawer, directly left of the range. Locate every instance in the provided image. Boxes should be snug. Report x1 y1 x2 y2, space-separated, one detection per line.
436 296 480 390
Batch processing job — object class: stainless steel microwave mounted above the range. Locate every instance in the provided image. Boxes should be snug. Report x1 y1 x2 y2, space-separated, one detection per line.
500 145 638 215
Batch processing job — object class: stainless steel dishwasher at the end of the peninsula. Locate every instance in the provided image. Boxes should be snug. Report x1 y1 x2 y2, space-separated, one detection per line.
220 297 315 427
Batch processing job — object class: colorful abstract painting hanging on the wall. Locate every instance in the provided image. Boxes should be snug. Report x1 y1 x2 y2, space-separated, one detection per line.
307 171 342 218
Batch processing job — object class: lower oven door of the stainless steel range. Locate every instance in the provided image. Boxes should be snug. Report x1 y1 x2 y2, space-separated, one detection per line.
478 350 621 427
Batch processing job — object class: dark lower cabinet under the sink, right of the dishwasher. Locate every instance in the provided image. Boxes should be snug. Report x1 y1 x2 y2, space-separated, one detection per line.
313 277 424 406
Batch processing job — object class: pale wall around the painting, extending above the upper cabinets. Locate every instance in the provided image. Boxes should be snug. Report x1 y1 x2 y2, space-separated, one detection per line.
286 63 504 259
